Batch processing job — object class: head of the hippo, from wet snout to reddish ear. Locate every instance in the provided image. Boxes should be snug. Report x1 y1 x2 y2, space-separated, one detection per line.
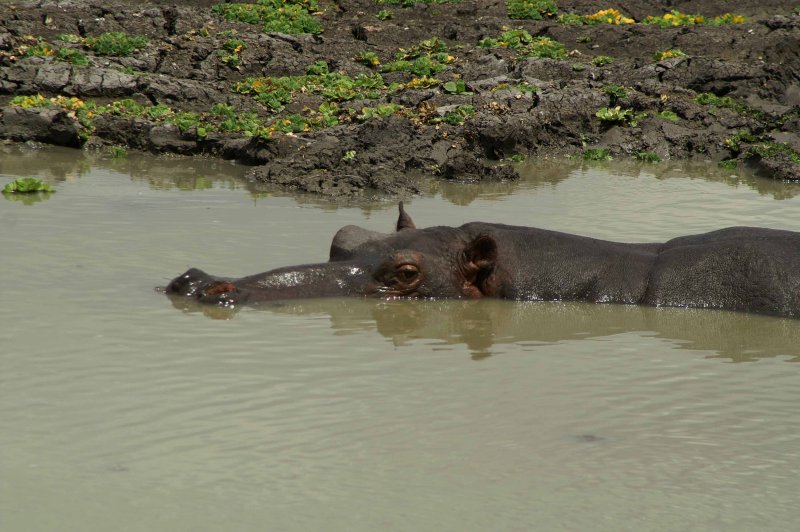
166 203 497 306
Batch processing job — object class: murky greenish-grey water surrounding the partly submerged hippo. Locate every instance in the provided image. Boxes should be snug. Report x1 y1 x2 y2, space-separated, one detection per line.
0 147 800 531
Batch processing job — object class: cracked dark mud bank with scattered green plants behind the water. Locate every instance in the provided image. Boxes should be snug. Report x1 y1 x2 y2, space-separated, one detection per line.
0 0 800 198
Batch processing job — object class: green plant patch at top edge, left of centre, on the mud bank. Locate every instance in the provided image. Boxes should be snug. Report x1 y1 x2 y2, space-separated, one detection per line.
216 0 322 35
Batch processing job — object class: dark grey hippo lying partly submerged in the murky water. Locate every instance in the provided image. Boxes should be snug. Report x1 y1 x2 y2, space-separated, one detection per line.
166 203 800 317
